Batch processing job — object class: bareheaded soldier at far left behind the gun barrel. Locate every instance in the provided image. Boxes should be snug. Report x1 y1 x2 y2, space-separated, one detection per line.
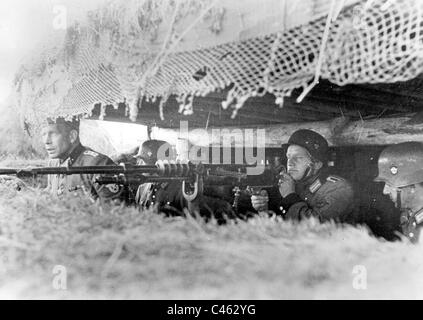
41 118 121 199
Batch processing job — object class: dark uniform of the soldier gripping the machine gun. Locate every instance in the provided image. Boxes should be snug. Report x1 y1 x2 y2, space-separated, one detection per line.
269 175 354 222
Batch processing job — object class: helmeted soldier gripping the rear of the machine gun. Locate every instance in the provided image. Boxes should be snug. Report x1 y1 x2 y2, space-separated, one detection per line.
251 130 354 222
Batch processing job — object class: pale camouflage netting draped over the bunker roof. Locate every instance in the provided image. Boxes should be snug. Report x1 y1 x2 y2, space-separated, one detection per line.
12 0 423 127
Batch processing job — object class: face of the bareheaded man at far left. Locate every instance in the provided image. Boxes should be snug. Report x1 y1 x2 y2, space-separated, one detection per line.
41 124 72 159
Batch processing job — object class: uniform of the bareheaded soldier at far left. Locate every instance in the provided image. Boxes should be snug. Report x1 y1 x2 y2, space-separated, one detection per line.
47 144 122 199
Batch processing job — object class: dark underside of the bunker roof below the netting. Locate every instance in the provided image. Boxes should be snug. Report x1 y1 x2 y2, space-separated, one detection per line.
91 75 423 128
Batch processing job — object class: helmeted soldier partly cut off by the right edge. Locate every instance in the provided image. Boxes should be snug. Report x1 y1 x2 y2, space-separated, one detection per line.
375 142 423 242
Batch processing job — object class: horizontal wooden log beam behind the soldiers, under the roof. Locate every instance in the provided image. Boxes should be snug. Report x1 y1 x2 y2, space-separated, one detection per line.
152 114 423 148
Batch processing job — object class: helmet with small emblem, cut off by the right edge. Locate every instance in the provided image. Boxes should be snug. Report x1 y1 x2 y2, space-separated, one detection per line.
374 142 423 188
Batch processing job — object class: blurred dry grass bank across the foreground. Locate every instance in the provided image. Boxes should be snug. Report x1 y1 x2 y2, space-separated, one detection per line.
0 185 423 299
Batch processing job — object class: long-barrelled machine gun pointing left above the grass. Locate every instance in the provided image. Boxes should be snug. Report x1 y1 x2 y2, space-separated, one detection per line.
0 161 284 211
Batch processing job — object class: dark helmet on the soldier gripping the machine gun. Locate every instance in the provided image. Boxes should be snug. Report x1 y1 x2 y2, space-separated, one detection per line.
282 129 329 164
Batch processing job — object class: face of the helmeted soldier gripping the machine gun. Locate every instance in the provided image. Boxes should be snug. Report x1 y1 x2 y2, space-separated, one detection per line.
286 145 312 181
